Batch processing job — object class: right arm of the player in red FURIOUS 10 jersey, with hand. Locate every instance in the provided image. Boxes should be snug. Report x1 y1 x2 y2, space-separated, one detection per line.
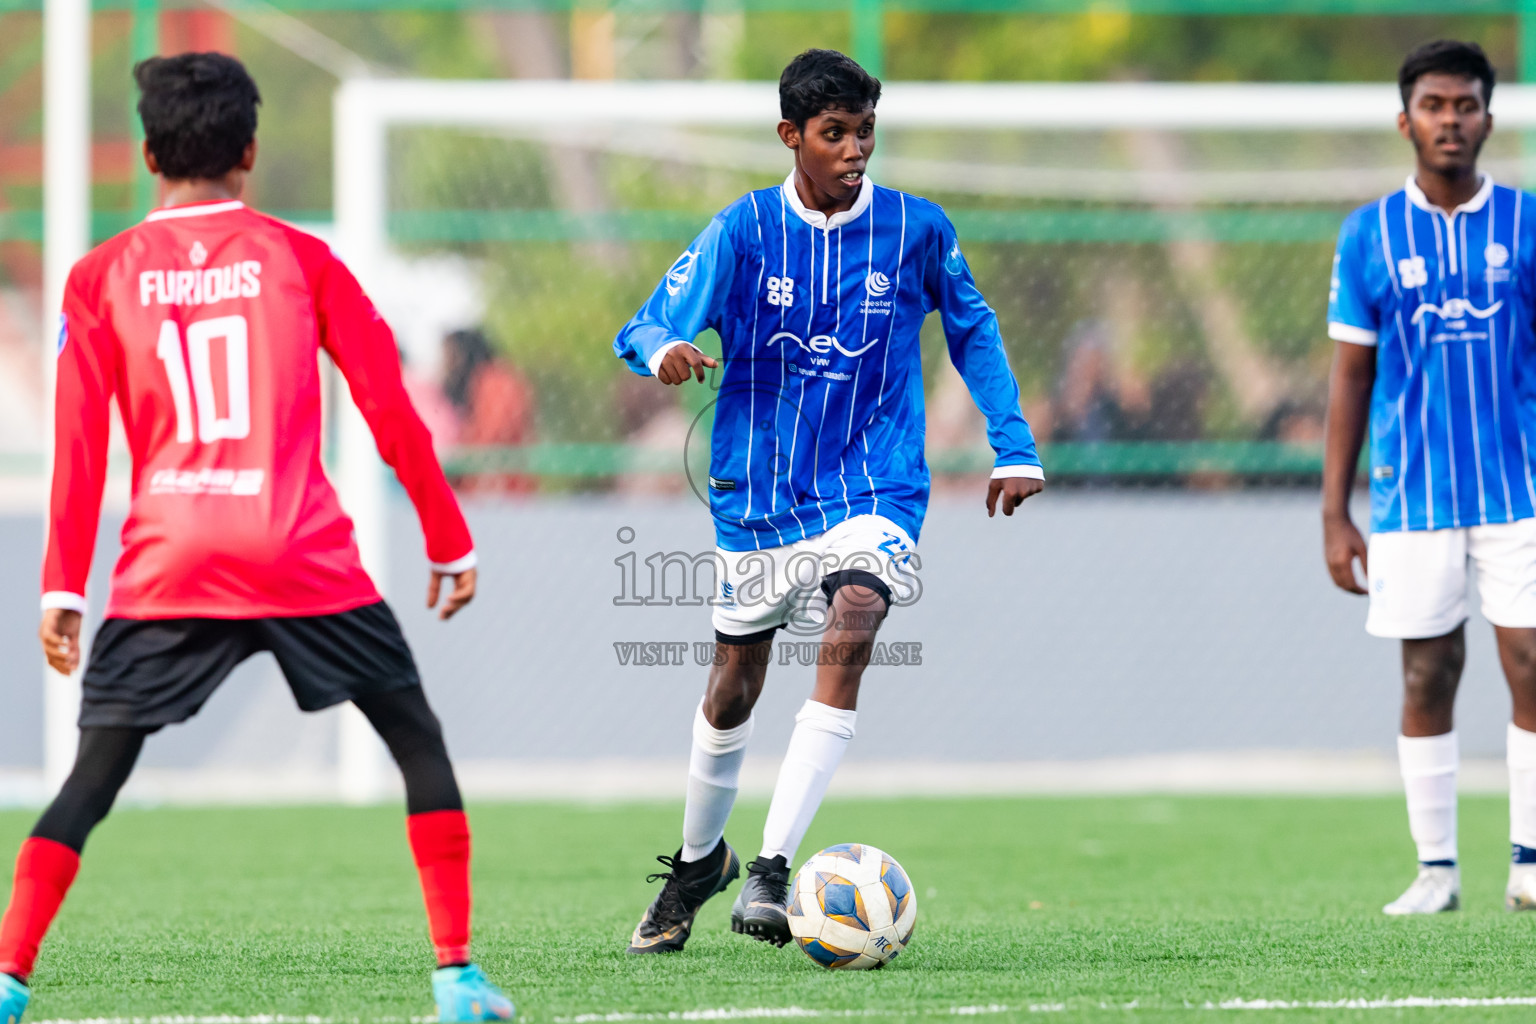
310 249 476 619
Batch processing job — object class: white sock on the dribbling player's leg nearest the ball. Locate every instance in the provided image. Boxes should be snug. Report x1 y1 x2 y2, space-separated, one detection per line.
762 700 859 867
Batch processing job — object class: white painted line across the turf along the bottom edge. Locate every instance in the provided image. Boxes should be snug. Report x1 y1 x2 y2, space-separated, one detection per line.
35 996 1536 1024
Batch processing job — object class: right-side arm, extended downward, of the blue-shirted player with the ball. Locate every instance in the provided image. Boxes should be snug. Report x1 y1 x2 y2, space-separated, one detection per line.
923 220 1046 516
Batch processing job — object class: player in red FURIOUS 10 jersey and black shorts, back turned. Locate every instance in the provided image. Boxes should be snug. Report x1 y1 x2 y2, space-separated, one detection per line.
0 54 513 1024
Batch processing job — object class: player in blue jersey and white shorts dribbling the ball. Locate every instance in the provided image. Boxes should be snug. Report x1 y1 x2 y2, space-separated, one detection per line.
613 49 1044 953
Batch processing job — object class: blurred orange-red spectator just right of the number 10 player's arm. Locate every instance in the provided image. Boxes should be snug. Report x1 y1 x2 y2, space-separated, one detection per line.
442 327 538 494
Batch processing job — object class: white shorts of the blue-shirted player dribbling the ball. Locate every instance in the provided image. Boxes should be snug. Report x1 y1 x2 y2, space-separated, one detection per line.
713 516 922 637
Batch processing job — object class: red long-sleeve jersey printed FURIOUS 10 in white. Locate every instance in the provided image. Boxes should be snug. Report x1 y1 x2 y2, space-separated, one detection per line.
43 201 475 619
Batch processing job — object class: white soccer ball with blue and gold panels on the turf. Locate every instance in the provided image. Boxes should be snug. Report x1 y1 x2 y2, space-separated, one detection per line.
790 843 917 970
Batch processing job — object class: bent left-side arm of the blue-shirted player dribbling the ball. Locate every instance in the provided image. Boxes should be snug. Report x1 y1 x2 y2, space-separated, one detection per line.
613 216 736 384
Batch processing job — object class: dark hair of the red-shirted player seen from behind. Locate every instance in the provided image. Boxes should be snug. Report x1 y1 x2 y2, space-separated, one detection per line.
134 54 261 180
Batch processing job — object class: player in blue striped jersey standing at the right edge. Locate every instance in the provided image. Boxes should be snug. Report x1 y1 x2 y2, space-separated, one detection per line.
1322 41 1536 915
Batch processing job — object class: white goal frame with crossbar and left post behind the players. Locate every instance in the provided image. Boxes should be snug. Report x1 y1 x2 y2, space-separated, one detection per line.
317 78 1536 800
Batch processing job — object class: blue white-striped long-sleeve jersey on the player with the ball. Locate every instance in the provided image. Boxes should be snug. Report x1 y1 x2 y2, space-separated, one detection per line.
613 175 1043 551
